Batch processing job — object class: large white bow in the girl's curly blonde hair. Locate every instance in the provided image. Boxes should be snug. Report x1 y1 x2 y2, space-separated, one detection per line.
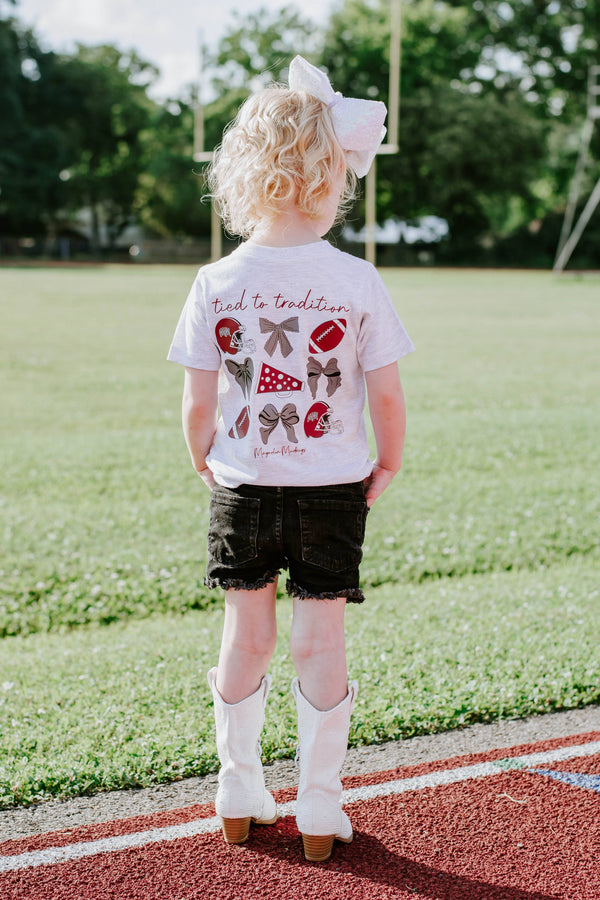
289 56 387 178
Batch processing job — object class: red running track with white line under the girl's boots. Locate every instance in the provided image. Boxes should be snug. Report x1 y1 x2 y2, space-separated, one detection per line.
0 732 600 900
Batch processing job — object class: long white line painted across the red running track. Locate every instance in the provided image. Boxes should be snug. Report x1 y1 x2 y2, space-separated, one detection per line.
0 741 600 873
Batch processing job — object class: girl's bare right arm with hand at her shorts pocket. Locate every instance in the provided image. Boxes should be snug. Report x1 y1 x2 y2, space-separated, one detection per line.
365 362 406 506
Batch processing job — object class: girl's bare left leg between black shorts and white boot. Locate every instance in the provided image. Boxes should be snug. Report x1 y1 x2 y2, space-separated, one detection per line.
217 580 277 704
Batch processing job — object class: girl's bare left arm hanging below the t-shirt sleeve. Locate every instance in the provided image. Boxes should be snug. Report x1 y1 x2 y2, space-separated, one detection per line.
181 367 219 490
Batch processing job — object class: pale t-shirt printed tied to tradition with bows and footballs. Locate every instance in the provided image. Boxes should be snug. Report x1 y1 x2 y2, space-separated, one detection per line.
168 241 414 487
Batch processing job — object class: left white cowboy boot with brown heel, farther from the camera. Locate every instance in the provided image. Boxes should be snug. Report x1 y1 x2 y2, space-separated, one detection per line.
208 668 277 844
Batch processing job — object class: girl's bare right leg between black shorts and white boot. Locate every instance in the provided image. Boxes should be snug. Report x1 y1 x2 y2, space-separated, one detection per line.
290 597 348 710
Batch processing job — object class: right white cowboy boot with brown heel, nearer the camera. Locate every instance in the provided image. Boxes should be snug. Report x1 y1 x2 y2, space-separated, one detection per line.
292 678 358 862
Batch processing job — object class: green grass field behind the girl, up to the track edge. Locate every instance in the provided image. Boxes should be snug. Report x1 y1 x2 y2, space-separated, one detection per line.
0 266 600 806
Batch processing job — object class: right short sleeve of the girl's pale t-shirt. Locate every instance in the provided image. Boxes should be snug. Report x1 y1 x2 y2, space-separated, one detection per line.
357 268 415 372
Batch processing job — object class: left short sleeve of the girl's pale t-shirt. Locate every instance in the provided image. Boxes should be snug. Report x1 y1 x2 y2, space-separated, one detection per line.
167 275 221 372
